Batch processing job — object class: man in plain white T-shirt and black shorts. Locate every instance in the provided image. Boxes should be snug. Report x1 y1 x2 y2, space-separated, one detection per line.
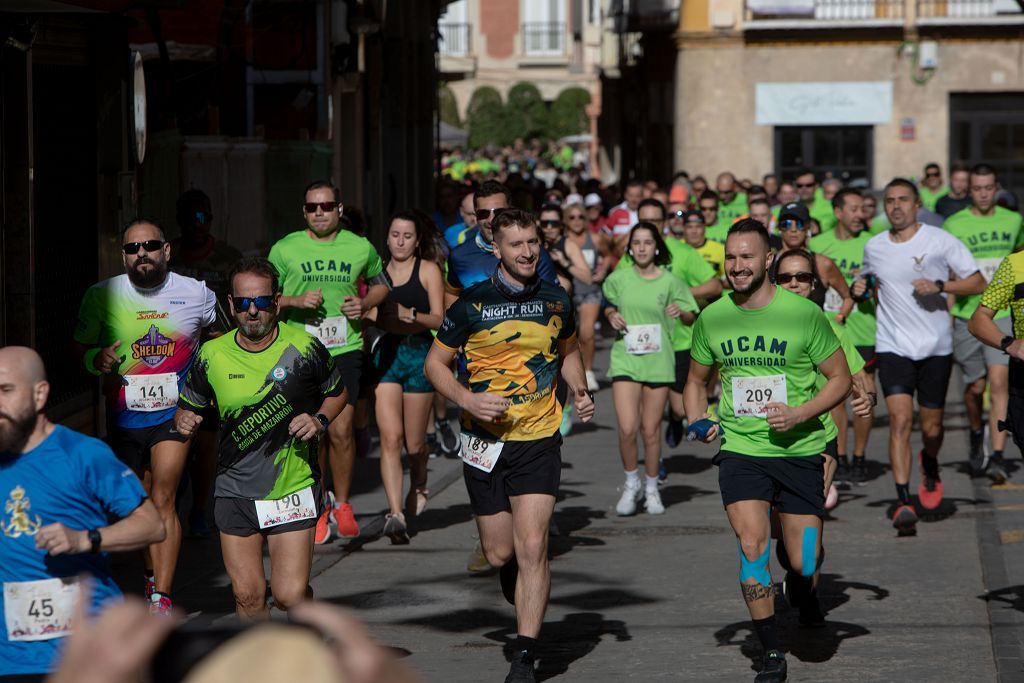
851 178 985 536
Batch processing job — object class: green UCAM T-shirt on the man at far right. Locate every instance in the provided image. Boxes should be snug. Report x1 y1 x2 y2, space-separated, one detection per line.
942 207 1024 319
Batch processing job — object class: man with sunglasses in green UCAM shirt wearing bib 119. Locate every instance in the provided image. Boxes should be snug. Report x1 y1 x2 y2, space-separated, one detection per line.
269 181 388 544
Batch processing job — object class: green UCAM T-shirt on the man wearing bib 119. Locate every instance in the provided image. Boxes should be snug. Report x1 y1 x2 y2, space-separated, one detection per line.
268 230 384 355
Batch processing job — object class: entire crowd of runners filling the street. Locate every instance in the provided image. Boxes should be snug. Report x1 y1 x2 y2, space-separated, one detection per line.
0 156 1024 683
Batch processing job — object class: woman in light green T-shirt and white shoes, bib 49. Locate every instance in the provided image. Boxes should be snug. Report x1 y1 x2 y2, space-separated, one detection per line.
602 221 698 515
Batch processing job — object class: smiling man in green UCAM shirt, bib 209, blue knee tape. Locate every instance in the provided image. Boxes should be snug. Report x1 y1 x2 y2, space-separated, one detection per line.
685 219 852 681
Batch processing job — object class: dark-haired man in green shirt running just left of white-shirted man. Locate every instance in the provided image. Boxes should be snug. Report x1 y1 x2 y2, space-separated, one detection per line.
811 187 876 484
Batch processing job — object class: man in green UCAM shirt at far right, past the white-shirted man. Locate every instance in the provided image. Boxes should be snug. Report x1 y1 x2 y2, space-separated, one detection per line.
942 164 1024 482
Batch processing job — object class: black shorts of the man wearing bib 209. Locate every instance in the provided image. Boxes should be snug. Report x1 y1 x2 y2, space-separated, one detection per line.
712 451 825 517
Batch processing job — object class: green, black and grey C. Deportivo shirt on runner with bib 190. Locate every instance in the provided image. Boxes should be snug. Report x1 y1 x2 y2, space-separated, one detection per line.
178 323 344 501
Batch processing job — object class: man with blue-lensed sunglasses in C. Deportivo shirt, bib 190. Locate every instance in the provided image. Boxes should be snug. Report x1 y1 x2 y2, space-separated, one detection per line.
174 258 347 620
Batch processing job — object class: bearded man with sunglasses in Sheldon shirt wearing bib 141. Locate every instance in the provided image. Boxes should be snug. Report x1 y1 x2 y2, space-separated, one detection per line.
74 219 217 614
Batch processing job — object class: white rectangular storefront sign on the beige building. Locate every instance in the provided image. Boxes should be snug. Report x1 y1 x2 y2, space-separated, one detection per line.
755 81 893 126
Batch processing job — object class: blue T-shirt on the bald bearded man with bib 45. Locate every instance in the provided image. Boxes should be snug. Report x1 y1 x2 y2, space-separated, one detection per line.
0 426 145 676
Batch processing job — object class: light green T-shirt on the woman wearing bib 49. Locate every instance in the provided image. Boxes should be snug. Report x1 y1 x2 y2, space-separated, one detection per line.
602 266 698 382
